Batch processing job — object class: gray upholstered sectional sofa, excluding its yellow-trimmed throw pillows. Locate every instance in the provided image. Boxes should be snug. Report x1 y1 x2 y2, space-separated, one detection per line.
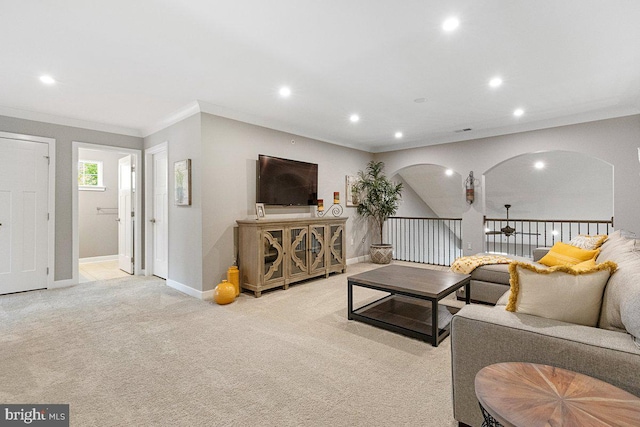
450 231 640 426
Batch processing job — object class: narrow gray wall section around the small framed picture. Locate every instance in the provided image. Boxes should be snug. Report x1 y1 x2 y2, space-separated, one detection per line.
144 114 201 291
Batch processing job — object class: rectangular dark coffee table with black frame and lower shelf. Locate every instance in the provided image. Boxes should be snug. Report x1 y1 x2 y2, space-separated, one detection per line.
347 265 471 347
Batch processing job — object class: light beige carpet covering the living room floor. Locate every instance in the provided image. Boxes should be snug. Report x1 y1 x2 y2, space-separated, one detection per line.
0 264 456 426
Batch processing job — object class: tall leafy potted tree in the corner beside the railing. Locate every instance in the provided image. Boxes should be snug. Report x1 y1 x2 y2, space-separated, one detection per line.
353 160 402 264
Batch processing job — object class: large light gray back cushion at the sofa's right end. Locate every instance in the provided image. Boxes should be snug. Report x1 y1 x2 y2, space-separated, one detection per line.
597 231 640 334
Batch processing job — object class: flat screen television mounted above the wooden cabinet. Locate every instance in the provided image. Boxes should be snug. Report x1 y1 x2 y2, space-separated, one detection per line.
256 154 318 206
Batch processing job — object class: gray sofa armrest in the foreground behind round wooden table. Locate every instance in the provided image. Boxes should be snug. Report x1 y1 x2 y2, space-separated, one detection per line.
450 305 640 426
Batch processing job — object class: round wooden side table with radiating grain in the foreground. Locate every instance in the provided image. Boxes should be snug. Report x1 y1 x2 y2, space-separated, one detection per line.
475 362 640 427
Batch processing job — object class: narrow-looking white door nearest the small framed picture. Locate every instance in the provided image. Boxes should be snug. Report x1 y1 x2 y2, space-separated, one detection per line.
151 151 169 279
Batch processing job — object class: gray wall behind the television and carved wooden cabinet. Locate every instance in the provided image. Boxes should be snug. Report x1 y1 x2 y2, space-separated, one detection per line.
201 114 372 291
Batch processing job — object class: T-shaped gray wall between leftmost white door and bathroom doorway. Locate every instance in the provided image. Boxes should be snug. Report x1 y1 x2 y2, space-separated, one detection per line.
0 116 143 280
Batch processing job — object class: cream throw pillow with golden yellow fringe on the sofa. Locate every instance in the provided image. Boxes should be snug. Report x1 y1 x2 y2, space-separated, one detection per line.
506 261 618 326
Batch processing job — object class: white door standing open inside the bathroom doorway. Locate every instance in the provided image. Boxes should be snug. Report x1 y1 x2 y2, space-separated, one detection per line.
116 155 134 274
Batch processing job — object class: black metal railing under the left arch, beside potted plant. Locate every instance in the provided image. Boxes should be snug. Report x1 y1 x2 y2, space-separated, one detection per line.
384 217 462 266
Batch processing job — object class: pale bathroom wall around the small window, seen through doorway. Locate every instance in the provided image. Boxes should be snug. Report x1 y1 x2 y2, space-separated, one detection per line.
78 148 123 258
